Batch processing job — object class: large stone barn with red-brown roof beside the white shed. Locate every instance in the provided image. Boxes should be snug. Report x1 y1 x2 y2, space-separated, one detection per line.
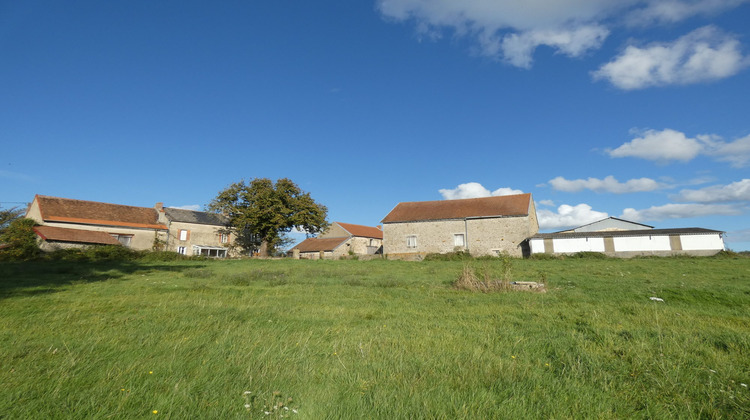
382 194 539 259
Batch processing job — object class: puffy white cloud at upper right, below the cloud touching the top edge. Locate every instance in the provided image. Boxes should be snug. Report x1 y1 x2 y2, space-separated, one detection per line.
593 26 749 90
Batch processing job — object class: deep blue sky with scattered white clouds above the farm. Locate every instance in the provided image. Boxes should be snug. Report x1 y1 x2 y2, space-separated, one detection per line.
0 0 750 250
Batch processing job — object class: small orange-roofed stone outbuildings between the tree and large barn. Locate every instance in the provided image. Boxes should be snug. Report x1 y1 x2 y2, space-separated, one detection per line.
290 222 383 259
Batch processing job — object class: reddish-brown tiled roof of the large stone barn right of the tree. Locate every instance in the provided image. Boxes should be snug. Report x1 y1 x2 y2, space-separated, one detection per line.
383 194 531 223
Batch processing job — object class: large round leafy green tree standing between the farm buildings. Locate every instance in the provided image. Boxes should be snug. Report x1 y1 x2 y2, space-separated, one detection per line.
208 178 328 257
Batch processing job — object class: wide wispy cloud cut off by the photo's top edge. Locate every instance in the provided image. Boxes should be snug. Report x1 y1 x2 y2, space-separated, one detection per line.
377 0 748 69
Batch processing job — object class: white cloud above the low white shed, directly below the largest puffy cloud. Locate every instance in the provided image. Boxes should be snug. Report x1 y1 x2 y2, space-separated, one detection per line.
607 128 750 167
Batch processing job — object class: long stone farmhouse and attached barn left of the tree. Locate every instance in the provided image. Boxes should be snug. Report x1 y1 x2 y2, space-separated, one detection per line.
26 195 232 258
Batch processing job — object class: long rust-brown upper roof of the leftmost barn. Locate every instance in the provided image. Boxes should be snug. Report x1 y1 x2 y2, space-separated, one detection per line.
36 195 167 229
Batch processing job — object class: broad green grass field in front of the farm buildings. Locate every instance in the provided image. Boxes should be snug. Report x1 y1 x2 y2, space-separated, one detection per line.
0 257 750 419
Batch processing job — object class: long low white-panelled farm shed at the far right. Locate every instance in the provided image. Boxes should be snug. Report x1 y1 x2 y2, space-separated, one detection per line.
529 217 724 258
